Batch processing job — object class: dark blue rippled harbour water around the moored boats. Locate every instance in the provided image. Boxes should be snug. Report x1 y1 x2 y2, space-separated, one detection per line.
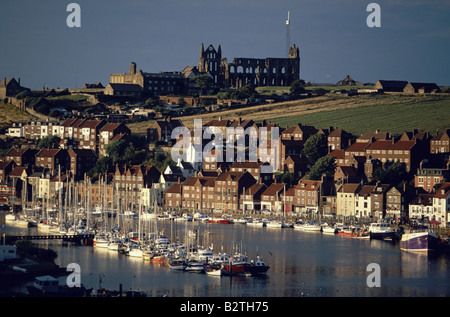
2 217 450 298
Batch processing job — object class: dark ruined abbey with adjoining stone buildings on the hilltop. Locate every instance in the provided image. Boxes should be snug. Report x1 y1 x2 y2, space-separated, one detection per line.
105 43 300 95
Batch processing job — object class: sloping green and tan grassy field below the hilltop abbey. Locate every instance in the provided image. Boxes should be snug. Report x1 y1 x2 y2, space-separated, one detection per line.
130 94 450 135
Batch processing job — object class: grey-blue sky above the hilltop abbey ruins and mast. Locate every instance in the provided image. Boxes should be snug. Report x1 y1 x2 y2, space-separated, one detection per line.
0 0 450 89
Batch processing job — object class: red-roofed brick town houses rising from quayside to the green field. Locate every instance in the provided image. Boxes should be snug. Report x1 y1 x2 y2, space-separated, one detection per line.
0 111 450 227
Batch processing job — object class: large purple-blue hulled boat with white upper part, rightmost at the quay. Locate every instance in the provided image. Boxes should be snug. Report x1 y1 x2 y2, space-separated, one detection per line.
400 230 438 253
